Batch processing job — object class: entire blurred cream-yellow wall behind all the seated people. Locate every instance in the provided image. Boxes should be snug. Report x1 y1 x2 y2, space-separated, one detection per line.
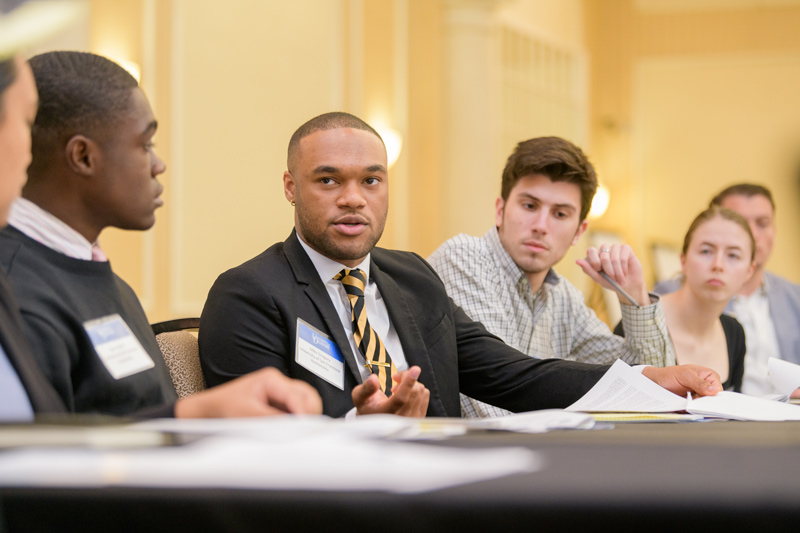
20 0 800 322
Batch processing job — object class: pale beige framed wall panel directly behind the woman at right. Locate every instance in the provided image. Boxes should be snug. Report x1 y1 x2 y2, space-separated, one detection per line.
634 54 800 282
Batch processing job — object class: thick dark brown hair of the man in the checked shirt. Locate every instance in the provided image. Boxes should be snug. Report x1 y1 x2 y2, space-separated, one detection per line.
500 137 597 220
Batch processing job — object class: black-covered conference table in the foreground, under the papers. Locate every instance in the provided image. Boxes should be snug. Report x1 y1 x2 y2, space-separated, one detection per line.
0 421 800 532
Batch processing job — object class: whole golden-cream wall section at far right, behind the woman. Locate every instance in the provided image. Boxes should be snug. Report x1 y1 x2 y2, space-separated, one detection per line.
584 0 800 282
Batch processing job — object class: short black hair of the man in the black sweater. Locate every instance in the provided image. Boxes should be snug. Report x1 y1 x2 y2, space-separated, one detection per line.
29 51 139 154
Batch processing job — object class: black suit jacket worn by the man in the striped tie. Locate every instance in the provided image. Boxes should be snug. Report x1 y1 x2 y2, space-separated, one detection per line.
200 232 608 417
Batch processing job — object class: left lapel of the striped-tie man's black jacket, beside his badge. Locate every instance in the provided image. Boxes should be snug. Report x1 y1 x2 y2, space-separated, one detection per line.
284 231 361 383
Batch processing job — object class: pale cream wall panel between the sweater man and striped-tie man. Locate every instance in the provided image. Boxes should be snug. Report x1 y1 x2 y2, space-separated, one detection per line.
170 0 344 314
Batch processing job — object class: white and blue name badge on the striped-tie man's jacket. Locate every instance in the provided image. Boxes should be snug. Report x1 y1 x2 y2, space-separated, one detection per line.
294 318 344 390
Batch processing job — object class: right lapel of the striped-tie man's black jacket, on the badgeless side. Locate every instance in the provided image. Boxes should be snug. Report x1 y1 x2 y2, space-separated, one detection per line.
369 256 446 412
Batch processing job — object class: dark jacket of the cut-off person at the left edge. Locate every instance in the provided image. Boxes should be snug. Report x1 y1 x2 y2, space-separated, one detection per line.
0 272 67 413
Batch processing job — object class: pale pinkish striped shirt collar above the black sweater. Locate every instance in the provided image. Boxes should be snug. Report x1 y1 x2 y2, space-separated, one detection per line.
8 198 108 261
